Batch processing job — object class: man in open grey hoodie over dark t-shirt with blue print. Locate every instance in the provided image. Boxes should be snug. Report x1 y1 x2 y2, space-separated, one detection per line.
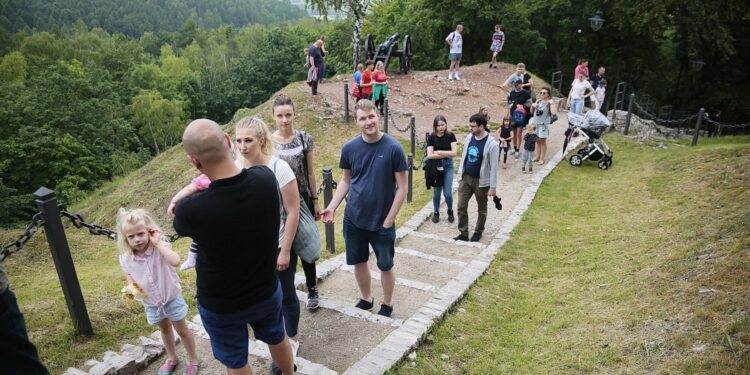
454 114 499 242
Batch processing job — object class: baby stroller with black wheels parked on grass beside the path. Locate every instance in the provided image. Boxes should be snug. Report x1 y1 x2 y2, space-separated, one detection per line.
568 110 613 170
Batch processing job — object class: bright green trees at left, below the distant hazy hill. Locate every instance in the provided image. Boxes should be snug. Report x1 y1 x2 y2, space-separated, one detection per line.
0 9 349 224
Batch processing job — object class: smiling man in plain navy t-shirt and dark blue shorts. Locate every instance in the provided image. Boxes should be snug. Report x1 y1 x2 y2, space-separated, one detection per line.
322 99 408 317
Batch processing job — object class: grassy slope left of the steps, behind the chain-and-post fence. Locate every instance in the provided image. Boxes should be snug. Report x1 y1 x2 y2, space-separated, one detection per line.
0 83 431 373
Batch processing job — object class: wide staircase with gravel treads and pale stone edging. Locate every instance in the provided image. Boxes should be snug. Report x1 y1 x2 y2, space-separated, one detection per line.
66 114 581 375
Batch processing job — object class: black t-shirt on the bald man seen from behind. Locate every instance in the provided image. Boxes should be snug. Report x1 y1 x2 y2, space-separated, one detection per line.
173 166 280 313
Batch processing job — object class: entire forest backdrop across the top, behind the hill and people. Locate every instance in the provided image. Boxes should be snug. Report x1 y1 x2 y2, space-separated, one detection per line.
0 0 750 225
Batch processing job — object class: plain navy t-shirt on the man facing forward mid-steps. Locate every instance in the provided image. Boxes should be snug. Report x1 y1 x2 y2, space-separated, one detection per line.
339 134 408 231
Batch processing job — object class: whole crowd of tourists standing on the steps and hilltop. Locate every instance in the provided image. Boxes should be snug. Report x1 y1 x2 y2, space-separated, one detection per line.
0 25 606 375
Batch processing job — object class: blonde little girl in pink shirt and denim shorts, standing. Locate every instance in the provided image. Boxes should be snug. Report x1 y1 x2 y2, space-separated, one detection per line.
117 208 200 375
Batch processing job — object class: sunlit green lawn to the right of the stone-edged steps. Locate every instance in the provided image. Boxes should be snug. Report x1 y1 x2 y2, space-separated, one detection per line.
390 136 750 374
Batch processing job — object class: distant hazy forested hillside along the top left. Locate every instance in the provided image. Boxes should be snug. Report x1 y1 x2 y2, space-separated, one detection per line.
0 0 307 36
